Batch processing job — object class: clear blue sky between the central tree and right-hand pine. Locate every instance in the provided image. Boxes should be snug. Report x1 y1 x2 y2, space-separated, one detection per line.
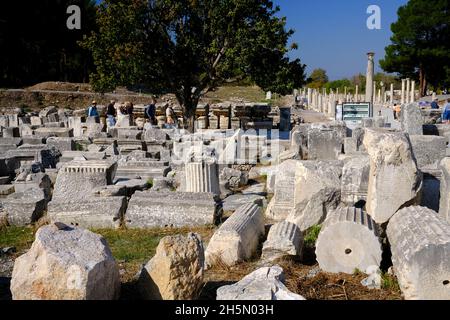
274 0 408 80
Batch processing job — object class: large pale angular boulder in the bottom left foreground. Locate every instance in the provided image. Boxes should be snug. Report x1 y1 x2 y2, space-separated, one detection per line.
11 223 120 300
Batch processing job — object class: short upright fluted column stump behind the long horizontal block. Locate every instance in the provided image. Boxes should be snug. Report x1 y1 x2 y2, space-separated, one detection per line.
185 161 220 194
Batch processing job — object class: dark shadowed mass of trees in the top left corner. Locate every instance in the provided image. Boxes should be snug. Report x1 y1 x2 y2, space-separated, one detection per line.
0 0 96 87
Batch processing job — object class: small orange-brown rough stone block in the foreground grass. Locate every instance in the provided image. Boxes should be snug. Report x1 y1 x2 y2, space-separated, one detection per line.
139 233 205 300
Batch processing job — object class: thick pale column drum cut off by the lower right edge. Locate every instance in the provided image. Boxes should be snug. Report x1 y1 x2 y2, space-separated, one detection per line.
387 207 450 300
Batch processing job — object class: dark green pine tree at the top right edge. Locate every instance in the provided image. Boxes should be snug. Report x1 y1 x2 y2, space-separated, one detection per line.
380 0 450 96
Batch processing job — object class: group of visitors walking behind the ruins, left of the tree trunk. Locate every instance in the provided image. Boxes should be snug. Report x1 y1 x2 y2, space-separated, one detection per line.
87 97 177 128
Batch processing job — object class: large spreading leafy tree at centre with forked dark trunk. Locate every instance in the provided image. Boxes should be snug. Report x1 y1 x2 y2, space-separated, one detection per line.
82 0 304 130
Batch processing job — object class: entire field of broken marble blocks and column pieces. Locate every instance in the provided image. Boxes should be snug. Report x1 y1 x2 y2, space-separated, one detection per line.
0 99 450 300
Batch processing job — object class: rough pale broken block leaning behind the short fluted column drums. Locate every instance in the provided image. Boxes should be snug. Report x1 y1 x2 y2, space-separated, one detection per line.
286 161 344 231
